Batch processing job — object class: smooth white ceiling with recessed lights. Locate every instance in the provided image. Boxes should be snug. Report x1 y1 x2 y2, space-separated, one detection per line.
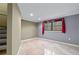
18 3 79 22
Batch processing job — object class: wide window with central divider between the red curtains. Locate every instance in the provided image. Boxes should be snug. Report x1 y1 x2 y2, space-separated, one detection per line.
45 21 62 31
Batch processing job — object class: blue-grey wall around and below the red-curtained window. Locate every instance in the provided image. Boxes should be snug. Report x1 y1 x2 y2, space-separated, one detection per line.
38 15 79 44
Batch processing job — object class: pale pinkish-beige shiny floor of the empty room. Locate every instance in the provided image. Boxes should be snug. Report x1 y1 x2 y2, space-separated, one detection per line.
18 38 79 55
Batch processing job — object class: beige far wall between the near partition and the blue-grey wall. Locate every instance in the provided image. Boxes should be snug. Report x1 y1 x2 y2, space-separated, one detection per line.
21 20 37 40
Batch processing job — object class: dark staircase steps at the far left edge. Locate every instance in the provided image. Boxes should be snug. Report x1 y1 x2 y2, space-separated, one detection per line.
0 26 7 50
